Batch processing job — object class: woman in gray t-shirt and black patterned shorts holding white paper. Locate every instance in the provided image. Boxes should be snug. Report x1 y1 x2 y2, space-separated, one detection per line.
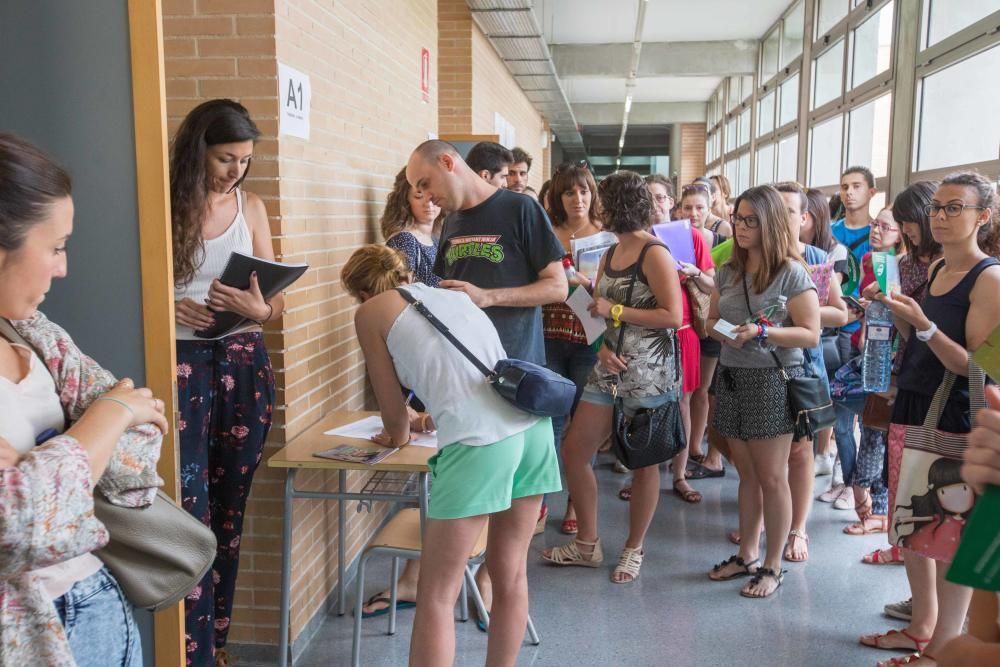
709 185 820 598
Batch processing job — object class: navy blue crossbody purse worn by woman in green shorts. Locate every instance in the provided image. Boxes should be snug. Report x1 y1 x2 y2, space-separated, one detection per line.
396 287 576 417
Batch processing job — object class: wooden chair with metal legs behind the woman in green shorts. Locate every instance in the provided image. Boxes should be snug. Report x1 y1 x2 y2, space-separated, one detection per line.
351 508 541 667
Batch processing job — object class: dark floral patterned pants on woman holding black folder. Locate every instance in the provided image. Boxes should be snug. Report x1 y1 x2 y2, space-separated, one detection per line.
177 332 274 667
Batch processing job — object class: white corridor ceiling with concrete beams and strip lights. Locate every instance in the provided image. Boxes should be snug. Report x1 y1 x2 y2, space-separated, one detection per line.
469 0 792 175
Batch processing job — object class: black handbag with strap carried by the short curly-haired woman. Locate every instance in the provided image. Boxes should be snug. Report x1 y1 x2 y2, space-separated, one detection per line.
611 242 687 470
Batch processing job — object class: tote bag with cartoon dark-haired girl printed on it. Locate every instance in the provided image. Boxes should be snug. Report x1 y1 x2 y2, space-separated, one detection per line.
889 355 986 561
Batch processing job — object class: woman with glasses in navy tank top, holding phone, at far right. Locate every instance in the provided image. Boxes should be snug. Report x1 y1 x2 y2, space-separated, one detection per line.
861 172 1000 667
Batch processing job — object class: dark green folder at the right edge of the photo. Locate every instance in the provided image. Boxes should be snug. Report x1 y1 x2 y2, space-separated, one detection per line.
946 486 1000 591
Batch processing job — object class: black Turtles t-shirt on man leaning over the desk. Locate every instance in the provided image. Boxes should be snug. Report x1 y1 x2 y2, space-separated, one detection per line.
434 189 564 364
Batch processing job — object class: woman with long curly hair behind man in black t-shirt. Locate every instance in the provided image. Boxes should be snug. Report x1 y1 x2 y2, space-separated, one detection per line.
381 167 441 287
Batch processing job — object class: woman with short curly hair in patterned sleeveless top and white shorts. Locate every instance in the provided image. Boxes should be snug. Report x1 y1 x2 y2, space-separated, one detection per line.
542 171 683 584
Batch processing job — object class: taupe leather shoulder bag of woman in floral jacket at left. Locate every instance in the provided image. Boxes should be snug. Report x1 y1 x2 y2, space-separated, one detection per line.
0 319 216 611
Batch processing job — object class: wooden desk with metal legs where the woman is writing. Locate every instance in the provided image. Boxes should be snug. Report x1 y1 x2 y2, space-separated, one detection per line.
267 411 437 667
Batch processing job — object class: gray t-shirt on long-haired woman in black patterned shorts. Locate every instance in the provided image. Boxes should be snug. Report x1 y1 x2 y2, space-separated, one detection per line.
715 261 816 368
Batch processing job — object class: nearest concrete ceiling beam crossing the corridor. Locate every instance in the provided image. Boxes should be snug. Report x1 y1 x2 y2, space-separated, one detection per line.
549 39 757 79
